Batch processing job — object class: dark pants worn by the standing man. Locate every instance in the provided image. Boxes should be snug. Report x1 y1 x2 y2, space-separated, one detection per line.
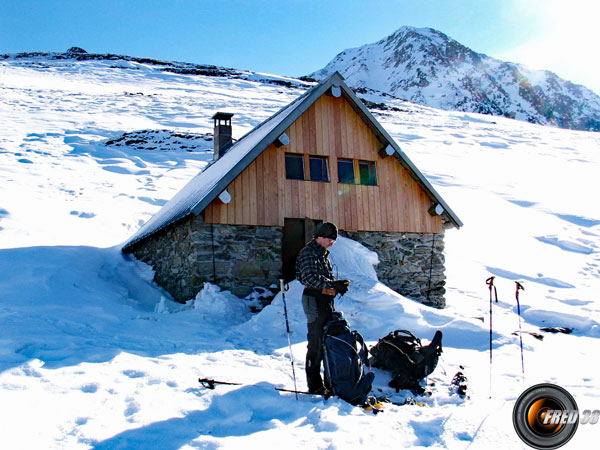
302 292 334 392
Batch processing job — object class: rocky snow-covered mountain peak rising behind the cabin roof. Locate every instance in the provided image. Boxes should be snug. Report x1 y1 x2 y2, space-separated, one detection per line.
309 27 600 131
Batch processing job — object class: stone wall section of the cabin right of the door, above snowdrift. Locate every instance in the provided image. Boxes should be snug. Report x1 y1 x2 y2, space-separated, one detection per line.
342 231 446 308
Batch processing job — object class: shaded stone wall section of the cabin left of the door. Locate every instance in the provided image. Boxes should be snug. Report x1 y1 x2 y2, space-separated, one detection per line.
126 214 283 301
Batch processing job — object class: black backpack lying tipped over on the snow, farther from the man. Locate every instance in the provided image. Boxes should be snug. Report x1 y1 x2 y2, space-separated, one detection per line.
369 330 442 392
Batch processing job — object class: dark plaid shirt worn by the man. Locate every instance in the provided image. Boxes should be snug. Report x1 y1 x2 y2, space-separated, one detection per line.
296 239 334 289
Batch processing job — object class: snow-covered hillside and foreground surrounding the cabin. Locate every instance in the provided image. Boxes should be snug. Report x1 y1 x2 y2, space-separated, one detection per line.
0 51 600 449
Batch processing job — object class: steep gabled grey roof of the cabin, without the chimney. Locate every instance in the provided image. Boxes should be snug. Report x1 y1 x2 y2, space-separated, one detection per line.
123 72 462 250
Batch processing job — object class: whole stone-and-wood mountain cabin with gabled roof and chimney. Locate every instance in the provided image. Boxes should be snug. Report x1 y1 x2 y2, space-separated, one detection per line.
123 72 462 307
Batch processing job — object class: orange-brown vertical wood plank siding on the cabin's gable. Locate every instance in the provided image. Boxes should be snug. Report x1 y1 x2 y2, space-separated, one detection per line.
205 95 442 233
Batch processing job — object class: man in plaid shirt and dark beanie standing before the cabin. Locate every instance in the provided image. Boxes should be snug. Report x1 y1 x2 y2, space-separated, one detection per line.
296 222 350 394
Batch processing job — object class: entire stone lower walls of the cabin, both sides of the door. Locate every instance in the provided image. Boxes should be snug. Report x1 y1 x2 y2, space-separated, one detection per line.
126 215 446 308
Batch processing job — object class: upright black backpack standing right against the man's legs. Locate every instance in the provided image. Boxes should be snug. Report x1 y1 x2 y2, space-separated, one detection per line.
323 311 375 405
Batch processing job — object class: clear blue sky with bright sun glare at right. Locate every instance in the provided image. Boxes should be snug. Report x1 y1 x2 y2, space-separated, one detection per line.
0 0 600 92
